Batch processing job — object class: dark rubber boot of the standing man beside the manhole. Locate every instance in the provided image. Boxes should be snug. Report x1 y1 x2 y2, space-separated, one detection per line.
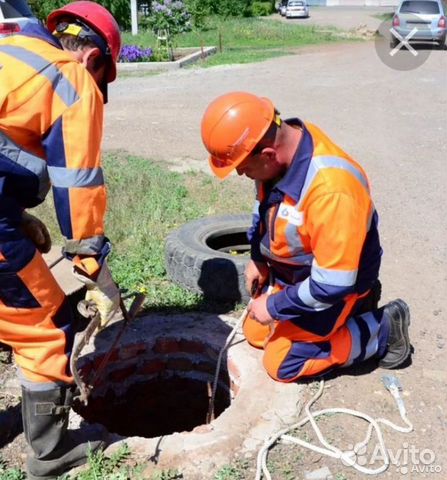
22 386 106 480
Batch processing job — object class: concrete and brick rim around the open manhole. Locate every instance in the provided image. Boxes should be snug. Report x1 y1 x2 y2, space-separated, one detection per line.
71 313 304 479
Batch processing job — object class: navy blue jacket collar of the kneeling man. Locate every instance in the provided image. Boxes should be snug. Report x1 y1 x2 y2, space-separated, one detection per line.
273 118 314 202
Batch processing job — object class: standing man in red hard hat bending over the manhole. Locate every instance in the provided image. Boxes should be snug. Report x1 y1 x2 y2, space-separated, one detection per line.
0 1 121 479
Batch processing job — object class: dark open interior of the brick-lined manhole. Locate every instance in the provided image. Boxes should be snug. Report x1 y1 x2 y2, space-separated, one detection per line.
74 340 235 438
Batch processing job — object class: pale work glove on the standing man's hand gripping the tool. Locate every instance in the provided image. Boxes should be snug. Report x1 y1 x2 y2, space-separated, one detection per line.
73 260 122 328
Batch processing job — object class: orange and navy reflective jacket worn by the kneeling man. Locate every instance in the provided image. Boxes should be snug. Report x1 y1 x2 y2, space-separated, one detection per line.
250 119 382 320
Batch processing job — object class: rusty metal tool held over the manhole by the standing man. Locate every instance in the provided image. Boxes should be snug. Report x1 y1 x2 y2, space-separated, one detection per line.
70 293 145 405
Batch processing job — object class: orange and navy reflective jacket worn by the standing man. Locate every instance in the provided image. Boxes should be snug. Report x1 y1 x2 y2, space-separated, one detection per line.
0 25 106 255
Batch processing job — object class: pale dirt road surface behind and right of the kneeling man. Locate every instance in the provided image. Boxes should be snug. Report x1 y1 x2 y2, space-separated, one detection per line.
0 9 447 480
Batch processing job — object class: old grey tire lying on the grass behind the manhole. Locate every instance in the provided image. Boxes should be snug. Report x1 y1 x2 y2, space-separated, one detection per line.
165 215 252 303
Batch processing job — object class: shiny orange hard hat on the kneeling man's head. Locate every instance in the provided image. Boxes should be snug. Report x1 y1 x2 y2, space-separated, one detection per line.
202 92 276 179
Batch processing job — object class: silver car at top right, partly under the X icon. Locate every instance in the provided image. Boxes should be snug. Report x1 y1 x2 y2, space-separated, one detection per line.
390 0 447 48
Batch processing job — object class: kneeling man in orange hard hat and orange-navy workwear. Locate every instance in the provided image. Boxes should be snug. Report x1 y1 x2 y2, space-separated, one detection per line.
202 92 410 382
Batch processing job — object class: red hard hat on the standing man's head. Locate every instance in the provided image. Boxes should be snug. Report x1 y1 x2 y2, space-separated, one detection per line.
47 1 121 83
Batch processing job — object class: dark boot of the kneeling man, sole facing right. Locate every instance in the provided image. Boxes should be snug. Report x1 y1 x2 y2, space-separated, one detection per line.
379 299 411 369
